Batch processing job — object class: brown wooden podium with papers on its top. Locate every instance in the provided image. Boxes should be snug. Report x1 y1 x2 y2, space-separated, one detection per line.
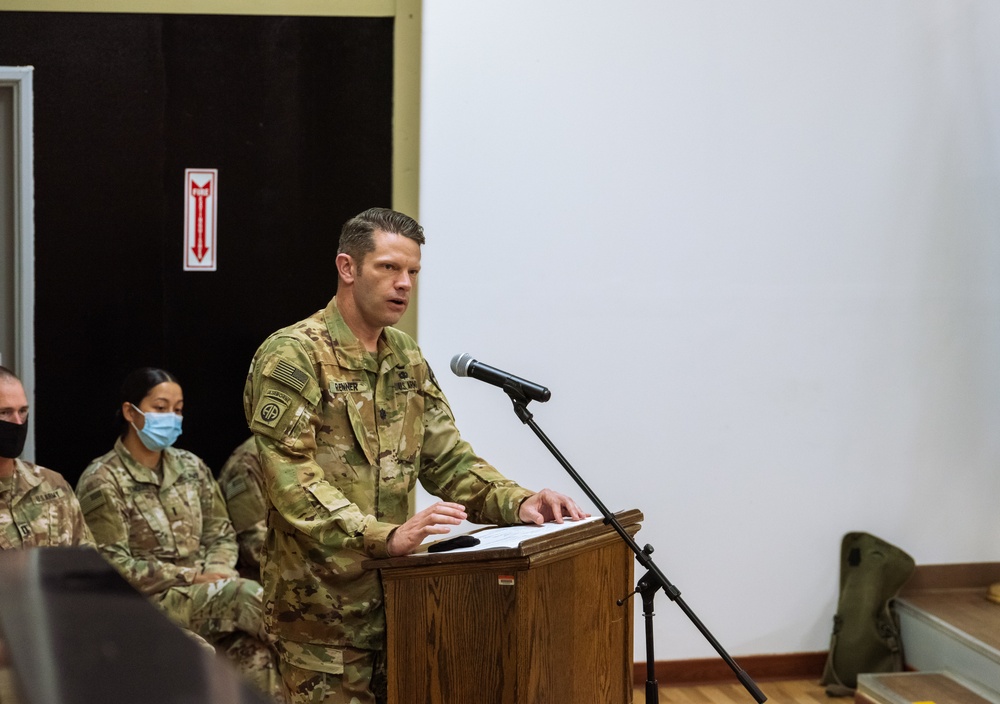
365 509 642 704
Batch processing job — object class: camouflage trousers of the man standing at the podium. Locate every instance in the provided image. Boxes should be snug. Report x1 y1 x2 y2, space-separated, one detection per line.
278 648 387 704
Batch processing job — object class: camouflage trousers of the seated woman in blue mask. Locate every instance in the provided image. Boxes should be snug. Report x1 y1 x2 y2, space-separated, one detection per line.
153 579 285 702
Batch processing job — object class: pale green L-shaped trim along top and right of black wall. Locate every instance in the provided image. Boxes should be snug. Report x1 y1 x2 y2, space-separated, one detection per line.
0 0 423 337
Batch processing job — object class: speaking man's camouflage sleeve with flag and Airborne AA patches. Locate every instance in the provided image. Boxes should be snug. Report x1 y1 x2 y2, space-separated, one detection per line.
243 338 398 557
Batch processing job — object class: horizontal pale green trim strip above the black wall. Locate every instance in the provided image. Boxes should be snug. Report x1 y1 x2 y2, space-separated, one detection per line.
0 0 397 17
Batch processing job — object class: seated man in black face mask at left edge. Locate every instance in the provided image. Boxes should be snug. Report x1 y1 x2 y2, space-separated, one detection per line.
0 367 94 550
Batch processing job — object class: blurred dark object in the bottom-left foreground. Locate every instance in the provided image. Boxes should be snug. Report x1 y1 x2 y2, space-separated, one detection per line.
0 547 266 704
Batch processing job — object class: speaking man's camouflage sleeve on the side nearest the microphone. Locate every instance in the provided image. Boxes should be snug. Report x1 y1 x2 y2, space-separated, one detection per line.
420 368 535 525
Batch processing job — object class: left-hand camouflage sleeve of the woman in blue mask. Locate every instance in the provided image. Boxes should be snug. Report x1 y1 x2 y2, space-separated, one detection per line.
76 468 198 596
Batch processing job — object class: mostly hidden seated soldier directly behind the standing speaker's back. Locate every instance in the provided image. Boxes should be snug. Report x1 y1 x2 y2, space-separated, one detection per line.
219 436 267 579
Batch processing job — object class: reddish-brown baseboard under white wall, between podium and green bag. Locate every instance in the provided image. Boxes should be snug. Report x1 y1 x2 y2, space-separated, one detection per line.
632 651 827 687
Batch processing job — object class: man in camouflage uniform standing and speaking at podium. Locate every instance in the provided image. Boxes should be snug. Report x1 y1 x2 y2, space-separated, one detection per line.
244 208 586 704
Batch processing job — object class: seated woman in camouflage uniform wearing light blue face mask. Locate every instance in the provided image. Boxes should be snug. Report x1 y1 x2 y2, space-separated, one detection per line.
77 367 284 701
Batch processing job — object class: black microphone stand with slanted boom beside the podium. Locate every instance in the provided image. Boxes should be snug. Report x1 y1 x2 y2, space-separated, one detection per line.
503 382 767 704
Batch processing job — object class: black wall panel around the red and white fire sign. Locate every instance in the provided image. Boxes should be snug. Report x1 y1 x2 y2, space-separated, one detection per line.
0 12 393 483
